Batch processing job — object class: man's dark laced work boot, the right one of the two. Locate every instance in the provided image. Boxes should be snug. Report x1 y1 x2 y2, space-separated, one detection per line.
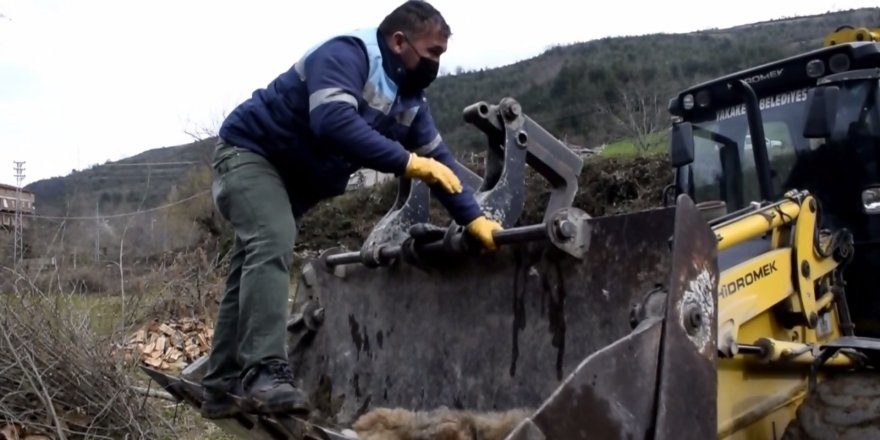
243 360 311 416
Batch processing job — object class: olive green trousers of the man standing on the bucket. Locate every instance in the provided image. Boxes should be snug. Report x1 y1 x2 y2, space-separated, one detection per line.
202 140 297 391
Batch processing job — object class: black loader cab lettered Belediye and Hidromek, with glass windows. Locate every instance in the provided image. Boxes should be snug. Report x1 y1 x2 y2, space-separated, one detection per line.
669 42 880 335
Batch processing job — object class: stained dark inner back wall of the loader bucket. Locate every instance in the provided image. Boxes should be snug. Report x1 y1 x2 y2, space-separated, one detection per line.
290 203 673 424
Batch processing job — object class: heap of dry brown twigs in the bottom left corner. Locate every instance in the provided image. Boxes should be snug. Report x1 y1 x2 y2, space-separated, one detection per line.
0 284 162 440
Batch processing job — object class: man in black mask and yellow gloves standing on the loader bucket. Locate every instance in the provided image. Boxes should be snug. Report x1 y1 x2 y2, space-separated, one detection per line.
202 1 501 418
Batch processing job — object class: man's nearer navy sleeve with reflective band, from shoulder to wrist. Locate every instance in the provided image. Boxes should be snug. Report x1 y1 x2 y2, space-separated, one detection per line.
304 37 409 175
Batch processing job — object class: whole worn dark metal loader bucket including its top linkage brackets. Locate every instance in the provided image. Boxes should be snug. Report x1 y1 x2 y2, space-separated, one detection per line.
149 98 717 439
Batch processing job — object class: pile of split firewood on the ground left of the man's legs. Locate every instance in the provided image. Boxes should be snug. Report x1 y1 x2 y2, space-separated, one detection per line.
124 317 214 371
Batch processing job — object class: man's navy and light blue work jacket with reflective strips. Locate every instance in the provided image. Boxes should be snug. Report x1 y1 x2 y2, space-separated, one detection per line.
219 28 481 225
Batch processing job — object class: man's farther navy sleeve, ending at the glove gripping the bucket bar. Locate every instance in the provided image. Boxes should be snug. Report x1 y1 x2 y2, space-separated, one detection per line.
406 101 483 225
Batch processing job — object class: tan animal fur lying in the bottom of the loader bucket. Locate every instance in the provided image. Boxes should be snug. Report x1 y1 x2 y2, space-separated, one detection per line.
352 407 532 440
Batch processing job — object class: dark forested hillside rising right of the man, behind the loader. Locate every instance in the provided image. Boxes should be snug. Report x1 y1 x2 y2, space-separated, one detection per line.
429 8 880 148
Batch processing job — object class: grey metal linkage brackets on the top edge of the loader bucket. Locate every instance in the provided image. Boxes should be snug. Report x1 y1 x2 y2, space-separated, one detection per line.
350 98 583 267
